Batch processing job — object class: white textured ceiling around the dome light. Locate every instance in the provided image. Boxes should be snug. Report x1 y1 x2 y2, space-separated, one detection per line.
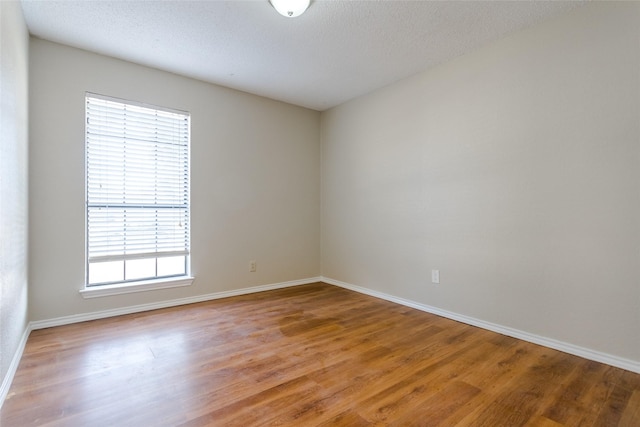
22 0 581 111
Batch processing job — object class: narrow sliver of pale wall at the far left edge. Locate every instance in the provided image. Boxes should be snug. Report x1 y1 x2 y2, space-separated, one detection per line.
0 1 29 396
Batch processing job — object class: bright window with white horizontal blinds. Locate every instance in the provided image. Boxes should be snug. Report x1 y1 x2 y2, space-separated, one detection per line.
85 94 190 287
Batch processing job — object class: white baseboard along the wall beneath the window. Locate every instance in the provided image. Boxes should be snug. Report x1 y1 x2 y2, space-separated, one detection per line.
30 277 321 330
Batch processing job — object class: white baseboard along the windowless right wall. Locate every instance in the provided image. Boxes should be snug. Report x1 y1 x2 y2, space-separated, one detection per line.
320 277 640 373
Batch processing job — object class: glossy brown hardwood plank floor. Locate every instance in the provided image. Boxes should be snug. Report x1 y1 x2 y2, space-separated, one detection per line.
0 283 640 427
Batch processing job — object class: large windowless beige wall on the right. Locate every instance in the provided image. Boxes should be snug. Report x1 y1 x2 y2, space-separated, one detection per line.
321 2 640 362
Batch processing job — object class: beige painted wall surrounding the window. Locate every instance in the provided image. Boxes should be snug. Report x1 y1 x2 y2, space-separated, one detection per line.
29 39 320 321
